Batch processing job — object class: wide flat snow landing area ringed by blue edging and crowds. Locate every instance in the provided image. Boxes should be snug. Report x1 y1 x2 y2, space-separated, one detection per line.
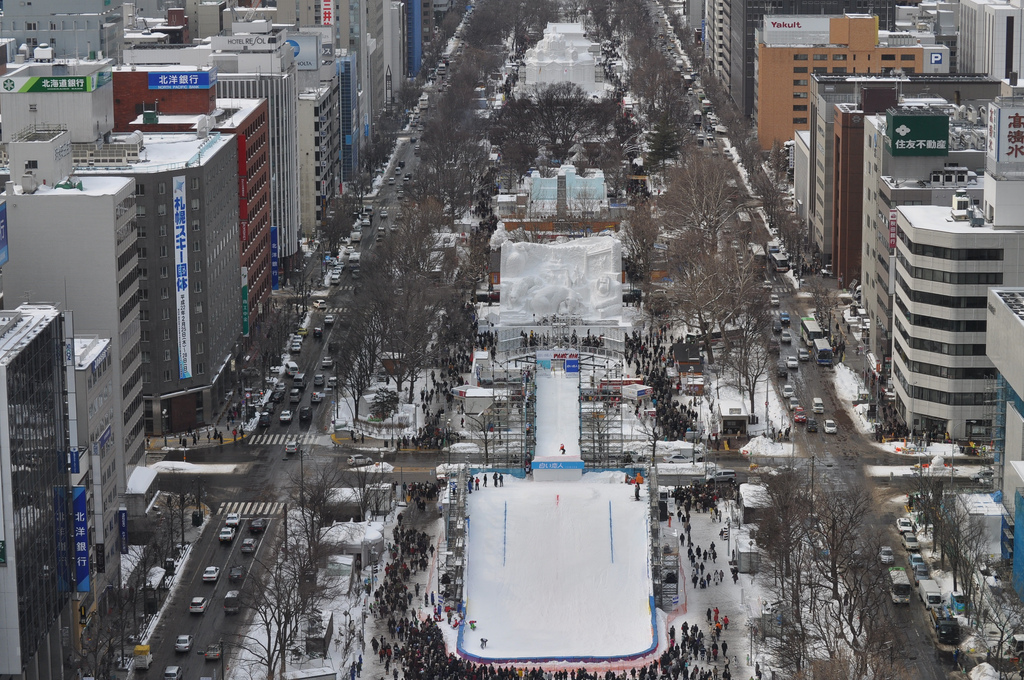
461 472 656 661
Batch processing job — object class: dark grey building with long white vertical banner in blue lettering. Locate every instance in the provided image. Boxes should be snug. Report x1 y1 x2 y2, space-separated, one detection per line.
76 130 243 434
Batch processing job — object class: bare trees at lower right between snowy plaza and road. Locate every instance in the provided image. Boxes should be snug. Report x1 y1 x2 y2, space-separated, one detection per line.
755 468 909 680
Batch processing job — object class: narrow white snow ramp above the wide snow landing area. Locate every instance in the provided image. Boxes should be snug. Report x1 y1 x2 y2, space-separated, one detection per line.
537 371 580 458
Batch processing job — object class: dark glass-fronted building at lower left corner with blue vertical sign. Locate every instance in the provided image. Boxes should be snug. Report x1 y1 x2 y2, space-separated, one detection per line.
0 304 71 679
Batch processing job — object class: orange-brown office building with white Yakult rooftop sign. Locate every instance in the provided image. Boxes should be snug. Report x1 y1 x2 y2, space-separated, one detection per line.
753 14 949 150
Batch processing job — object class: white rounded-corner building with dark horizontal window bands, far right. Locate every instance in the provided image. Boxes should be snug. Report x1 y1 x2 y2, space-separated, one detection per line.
893 97 1024 439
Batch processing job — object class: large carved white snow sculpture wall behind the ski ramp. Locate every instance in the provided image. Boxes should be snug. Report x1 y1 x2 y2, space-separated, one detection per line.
499 237 623 326
